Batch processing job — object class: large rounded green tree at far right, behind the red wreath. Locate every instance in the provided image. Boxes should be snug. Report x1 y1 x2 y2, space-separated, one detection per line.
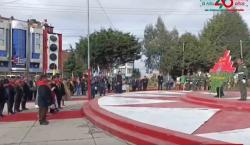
200 12 250 70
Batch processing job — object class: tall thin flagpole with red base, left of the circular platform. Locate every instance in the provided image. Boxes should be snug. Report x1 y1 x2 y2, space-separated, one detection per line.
87 0 91 100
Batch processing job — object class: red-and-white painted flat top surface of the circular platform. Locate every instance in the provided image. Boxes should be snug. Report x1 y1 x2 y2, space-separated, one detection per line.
98 91 250 145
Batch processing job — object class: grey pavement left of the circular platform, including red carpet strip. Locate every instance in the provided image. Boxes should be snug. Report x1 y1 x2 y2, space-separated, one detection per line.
0 96 132 145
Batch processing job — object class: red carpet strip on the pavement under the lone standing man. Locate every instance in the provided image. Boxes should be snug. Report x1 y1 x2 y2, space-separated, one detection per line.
0 110 84 122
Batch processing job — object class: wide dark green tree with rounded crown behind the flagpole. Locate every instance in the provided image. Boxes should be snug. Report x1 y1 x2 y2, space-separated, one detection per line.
76 29 141 69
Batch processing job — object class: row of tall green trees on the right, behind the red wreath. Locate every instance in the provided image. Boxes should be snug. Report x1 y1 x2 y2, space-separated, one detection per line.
143 12 250 76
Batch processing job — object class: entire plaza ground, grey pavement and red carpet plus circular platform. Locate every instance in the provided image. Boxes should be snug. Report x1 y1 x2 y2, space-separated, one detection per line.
0 91 250 145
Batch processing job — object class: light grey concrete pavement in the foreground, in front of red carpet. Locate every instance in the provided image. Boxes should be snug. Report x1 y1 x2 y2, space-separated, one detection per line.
0 118 132 145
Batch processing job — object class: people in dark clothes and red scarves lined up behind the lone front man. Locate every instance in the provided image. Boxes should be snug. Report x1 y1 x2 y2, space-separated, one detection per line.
0 76 74 124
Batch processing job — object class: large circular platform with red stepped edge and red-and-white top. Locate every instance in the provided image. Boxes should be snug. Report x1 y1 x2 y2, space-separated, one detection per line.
83 91 250 145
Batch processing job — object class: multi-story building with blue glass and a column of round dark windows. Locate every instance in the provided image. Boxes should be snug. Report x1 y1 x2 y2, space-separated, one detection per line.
0 16 62 73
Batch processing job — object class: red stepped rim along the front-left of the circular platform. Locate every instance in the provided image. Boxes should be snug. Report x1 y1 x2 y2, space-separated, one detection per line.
83 99 228 145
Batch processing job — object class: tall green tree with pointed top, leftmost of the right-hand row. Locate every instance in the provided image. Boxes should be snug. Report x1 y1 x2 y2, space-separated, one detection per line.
143 17 178 72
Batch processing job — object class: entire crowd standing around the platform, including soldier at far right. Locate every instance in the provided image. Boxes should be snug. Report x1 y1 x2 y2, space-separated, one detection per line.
0 58 248 125
